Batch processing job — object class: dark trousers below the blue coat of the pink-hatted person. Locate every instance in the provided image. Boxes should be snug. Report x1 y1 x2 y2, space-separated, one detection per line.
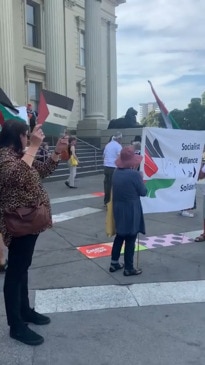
111 234 137 270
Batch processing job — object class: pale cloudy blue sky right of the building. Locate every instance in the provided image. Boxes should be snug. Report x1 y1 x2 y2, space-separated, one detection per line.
116 0 205 117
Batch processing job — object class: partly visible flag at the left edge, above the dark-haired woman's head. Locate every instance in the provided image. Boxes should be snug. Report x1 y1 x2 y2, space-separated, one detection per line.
0 88 26 125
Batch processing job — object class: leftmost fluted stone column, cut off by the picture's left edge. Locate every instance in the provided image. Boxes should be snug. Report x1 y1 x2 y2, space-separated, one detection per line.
0 0 16 101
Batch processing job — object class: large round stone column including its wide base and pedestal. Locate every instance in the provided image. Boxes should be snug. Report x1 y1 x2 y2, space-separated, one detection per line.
77 0 108 146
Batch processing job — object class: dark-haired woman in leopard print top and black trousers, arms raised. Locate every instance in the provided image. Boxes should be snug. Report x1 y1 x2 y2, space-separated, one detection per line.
0 120 68 346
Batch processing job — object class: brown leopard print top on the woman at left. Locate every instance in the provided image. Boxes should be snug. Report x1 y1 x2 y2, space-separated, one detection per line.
0 147 58 246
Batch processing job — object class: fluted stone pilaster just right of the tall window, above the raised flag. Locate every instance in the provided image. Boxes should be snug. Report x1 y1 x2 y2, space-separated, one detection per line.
44 0 66 95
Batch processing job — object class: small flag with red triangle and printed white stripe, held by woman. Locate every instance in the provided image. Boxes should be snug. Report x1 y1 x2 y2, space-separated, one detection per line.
38 89 74 137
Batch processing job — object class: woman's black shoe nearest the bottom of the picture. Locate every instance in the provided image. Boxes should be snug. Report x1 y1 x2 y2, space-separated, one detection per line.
10 324 44 346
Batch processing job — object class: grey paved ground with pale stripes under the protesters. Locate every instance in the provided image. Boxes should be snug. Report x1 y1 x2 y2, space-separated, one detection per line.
0 175 205 365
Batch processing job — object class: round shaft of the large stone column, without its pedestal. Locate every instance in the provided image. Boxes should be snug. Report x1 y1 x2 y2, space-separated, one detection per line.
85 0 104 119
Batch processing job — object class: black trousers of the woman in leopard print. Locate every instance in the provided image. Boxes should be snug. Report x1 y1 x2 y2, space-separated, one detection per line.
4 235 38 328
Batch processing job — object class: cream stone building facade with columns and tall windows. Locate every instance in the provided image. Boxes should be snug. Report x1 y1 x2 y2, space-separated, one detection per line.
0 0 126 130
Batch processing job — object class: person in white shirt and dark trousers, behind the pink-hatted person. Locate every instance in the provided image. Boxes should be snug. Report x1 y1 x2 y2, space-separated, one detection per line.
103 132 122 206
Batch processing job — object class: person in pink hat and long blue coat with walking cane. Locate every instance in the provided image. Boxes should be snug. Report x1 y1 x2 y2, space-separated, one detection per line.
109 146 147 276
